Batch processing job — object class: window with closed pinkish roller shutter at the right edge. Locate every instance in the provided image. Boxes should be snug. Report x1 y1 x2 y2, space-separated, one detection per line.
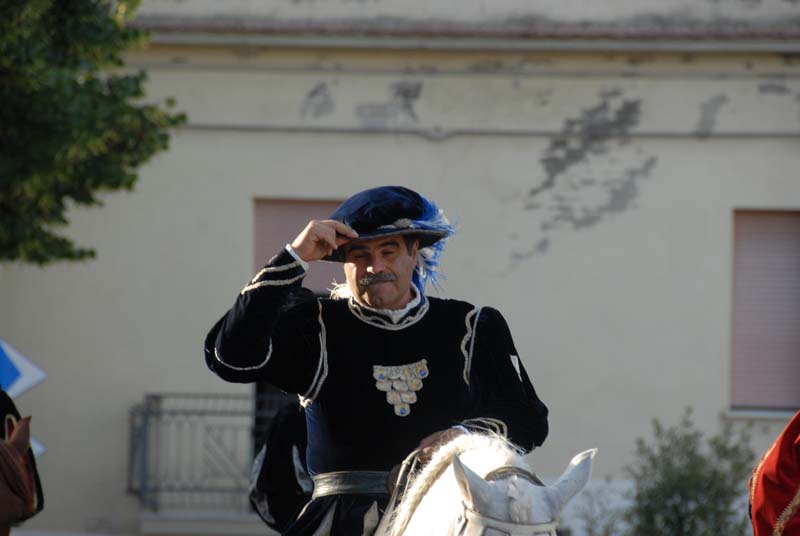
731 210 800 410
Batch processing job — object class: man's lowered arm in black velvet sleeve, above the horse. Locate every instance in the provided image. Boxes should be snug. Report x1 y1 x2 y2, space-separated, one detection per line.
465 307 548 450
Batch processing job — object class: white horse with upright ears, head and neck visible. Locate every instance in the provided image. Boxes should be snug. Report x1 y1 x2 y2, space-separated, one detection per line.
375 433 597 536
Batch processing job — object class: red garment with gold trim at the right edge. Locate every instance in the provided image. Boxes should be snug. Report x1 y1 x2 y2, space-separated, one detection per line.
750 412 800 536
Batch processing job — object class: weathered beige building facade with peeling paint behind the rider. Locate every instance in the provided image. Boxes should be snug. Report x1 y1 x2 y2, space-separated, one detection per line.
0 0 800 535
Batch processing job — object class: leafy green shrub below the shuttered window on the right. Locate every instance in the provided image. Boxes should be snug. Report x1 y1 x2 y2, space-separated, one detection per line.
625 409 755 536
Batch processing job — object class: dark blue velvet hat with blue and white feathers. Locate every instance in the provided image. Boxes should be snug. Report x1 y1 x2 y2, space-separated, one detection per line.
324 186 454 288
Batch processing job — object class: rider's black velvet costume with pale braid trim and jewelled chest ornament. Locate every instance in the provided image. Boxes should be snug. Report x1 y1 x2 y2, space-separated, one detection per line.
205 251 548 536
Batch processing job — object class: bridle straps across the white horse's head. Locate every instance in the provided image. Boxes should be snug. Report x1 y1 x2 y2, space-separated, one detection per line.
448 465 558 536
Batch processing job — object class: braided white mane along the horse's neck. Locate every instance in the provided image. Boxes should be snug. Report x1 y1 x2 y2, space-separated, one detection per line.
388 432 524 536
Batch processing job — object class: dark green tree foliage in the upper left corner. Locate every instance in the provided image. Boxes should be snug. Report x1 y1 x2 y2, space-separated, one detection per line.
0 0 185 264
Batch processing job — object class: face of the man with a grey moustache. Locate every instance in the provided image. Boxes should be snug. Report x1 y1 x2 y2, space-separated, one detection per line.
343 236 419 309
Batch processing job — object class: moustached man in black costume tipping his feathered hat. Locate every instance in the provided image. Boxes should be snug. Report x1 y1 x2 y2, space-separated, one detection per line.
205 187 548 536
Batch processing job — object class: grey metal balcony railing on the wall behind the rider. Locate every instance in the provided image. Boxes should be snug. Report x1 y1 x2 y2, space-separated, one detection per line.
128 390 297 513
